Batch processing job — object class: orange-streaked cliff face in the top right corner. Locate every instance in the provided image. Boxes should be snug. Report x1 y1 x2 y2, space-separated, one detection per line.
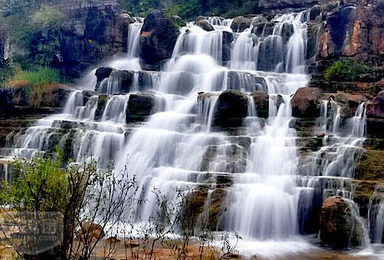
316 1 384 65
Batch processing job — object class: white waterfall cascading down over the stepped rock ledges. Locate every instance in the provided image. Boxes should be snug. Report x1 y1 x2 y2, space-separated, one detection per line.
0 12 380 255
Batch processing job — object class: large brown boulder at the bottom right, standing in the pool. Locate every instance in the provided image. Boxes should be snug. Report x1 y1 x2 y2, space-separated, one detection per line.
320 197 363 249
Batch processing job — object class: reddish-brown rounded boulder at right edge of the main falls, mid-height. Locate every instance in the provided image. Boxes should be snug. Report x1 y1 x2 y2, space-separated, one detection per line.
291 87 322 118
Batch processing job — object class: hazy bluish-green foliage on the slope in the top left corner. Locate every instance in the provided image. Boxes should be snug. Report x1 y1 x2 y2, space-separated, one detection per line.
2 3 65 69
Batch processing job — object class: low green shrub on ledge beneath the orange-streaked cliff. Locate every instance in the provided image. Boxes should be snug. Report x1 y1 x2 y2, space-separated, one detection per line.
325 60 369 81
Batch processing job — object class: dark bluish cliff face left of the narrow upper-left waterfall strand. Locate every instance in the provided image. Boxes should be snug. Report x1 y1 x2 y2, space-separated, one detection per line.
51 0 130 76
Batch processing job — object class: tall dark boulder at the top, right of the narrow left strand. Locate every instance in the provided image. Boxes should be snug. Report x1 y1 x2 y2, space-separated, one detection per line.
140 10 180 70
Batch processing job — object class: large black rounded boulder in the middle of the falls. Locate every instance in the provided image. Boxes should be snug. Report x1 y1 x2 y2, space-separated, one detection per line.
214 90 248 127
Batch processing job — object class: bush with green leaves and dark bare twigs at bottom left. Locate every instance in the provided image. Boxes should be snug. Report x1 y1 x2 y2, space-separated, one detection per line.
0 155 137 260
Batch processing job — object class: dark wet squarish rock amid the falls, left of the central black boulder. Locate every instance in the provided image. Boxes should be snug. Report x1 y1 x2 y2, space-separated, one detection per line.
126 93 156 123
